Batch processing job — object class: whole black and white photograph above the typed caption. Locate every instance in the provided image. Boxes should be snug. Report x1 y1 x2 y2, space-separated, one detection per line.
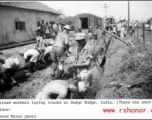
0 1 152 100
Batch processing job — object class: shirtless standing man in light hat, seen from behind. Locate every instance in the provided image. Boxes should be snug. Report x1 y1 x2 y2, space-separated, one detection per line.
51 25 70 78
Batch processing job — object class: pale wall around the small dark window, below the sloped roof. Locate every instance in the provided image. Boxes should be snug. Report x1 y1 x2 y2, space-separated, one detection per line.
0 6 58 44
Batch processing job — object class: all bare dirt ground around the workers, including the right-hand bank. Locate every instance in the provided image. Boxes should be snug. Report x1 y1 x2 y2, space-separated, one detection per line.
0 31 152 99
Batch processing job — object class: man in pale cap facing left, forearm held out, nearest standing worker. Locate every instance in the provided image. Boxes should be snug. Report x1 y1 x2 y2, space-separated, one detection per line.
68 33 93 92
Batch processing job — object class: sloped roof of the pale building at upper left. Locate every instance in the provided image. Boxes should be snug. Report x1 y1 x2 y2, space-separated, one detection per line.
0 2 61 15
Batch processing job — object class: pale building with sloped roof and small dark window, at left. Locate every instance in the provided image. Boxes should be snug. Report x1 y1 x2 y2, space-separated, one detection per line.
0 2 60 44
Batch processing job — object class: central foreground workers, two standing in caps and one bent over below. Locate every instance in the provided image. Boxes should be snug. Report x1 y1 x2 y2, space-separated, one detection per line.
36 22 104 99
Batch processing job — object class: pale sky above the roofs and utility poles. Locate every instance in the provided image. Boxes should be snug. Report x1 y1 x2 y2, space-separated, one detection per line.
39 1 152 21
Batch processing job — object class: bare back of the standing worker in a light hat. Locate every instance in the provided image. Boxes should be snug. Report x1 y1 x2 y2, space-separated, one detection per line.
53 32 68 47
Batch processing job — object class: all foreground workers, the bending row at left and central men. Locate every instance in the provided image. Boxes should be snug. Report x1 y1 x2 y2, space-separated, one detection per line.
0 21 104 99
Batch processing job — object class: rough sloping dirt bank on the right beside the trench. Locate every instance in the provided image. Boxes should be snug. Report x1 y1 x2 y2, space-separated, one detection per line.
96 39 152 99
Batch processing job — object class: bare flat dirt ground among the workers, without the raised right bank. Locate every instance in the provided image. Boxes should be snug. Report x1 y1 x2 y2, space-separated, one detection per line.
0 35 107 99
